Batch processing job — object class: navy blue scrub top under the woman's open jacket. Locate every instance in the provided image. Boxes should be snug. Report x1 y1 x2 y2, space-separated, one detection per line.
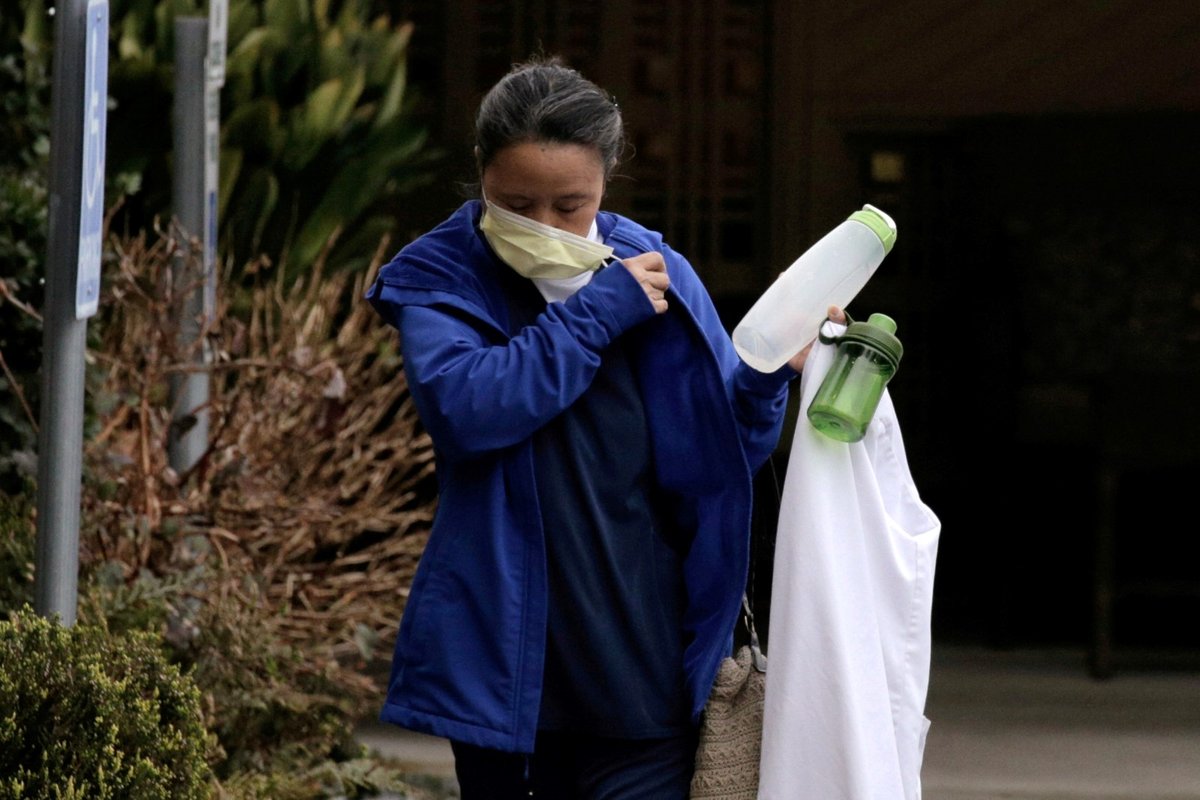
503 265 690 739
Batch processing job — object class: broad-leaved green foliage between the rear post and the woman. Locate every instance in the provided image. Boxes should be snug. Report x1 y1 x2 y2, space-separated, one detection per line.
213 0 431 276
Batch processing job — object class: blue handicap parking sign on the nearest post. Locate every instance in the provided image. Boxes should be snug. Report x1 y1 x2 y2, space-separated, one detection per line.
76 0 108 319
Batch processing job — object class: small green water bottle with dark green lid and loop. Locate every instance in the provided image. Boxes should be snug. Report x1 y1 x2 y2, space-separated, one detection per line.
809 314 904 441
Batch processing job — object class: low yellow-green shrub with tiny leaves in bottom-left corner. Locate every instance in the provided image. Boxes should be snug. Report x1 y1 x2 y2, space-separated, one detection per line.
0 608 212 800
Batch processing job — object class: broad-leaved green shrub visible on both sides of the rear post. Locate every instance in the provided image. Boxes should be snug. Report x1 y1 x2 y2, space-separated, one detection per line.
99 0 432 277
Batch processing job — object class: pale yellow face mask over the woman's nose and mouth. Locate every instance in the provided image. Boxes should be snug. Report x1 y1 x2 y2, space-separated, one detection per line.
479 198 612 278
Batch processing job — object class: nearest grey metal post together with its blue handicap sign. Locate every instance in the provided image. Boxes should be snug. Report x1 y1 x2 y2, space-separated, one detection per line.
35 0 108 625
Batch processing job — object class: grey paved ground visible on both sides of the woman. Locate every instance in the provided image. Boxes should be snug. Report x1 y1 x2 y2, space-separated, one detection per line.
360 645 1200 800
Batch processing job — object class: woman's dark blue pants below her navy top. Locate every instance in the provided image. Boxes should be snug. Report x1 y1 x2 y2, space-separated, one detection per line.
450 732 696 800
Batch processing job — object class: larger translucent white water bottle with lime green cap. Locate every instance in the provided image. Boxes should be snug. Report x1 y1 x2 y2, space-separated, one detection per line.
733 205 896 372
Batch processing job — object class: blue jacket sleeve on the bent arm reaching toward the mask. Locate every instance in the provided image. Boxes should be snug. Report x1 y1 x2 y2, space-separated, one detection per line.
382 265 654 458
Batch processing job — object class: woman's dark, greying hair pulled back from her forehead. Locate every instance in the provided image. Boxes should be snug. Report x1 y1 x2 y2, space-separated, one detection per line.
475 58 625 178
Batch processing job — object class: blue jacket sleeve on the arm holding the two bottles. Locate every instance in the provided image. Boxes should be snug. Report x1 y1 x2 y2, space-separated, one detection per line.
662 243 798 471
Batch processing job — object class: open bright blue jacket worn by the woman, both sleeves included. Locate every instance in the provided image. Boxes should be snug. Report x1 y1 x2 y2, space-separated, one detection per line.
367 201 796 752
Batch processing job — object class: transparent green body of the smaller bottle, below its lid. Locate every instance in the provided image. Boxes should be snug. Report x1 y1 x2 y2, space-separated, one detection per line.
808 342 895 441
